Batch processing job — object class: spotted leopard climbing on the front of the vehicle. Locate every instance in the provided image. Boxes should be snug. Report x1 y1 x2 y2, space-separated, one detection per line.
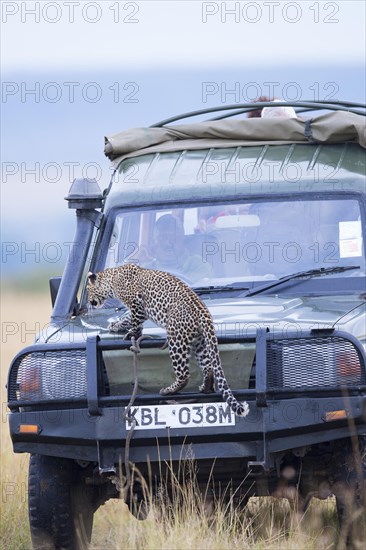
87 263 249 417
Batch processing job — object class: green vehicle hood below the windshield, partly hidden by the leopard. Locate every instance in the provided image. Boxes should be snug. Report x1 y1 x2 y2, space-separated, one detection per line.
41 294 366 342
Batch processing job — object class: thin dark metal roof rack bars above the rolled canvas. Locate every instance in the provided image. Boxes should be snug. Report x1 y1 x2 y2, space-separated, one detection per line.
150 101 366 128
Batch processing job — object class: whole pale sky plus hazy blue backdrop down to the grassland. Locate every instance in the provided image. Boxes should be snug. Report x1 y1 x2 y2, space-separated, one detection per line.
0 0 366 277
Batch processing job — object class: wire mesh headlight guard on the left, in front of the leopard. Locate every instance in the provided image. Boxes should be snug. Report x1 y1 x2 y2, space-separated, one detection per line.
9 350 87 401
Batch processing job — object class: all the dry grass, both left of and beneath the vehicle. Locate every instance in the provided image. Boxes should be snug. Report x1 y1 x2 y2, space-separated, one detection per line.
0 291 348 550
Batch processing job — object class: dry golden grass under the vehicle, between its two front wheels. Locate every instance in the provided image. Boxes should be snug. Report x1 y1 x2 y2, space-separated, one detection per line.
92 486 337 550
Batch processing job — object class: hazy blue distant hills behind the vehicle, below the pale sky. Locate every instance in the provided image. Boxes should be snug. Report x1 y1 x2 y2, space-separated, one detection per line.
1 66 365 278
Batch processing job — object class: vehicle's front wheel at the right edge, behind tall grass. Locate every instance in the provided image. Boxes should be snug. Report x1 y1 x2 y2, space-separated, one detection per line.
333 437 366 548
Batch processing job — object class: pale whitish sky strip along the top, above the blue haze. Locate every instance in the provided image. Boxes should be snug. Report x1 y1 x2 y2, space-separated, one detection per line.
1 0 366 71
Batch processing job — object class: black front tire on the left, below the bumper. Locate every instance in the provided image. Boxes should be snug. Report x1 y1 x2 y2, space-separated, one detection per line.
28 455 98 550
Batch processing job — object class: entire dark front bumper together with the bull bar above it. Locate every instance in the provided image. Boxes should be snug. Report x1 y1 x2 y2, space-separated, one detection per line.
8 330 366 471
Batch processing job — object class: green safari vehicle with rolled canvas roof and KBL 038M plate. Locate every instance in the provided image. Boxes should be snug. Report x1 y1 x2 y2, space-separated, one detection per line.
8 102 366 548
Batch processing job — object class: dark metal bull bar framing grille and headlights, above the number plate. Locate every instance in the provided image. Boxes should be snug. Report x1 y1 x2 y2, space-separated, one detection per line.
7 328 366 416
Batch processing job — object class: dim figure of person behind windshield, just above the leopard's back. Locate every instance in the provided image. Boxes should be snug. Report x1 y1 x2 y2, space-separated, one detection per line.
144 214 211 281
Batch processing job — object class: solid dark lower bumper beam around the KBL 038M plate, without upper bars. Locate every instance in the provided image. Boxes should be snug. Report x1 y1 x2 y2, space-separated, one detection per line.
9 395 366 470
